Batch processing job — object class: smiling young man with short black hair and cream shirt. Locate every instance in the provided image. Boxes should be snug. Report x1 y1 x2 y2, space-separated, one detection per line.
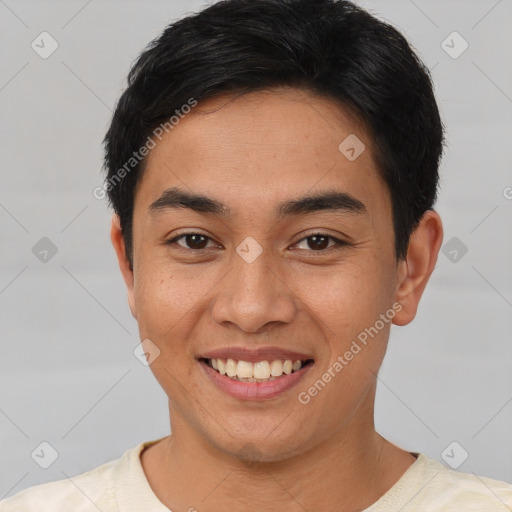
0 0 512 512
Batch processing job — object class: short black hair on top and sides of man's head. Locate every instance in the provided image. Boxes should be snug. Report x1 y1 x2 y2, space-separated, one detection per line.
104 0 443 265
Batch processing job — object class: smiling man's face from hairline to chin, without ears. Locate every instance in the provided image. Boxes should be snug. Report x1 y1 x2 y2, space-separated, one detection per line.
121 89 400 460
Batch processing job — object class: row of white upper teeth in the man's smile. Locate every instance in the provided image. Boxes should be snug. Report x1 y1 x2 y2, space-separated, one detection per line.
209 359 302 379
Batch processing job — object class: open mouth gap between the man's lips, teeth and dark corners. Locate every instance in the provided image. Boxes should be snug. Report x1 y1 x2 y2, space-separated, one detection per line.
200 358 314 382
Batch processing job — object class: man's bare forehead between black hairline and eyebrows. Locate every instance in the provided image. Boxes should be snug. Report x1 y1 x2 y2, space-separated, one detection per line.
136 89 389 219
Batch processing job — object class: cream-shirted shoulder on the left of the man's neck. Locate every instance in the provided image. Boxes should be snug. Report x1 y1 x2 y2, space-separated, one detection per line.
0 445 141 512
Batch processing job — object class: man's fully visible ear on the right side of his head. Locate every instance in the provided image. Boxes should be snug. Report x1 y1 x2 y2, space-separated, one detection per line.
393 210 443 325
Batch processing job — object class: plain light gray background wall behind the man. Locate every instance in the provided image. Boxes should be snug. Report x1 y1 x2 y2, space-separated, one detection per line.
0 0 512 498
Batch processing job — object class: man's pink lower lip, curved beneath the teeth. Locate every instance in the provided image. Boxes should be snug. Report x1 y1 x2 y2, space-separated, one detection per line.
199 360 313 400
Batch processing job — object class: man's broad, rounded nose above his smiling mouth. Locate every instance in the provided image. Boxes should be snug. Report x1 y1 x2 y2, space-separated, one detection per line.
212 247 297 333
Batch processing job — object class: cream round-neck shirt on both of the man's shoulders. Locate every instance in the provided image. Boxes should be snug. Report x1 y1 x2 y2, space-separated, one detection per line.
0 439 512 512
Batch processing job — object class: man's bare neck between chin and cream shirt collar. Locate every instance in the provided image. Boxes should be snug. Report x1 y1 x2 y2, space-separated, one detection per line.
141 394 415 512
